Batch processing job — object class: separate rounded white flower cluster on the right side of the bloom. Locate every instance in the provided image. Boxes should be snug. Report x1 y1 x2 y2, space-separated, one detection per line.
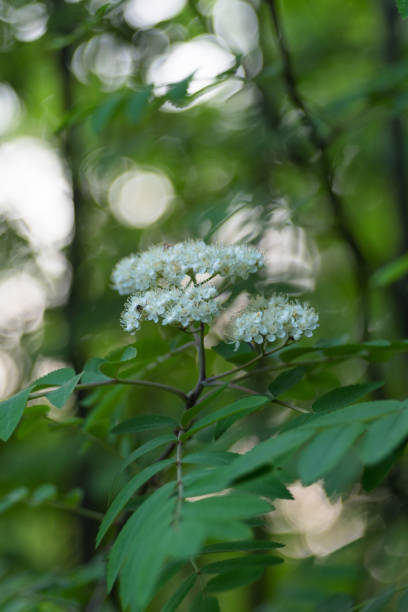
230 295 319 347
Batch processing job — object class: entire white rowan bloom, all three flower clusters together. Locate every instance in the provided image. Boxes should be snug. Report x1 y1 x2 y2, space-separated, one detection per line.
112 240 318 345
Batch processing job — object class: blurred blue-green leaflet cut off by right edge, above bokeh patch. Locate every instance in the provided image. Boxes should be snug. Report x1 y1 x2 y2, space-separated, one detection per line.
361 409 408 465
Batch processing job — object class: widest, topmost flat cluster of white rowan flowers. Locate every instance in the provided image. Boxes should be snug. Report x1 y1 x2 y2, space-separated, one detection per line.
112 240 264 295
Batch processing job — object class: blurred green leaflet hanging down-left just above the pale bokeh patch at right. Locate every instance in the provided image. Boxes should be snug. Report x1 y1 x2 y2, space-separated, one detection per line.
299 423 364 485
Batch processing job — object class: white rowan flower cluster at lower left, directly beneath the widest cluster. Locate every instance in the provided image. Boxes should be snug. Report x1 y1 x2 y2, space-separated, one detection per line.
121 285 219 333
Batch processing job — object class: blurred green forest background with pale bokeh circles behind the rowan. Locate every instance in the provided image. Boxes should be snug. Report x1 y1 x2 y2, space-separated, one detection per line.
0 0 408 612
